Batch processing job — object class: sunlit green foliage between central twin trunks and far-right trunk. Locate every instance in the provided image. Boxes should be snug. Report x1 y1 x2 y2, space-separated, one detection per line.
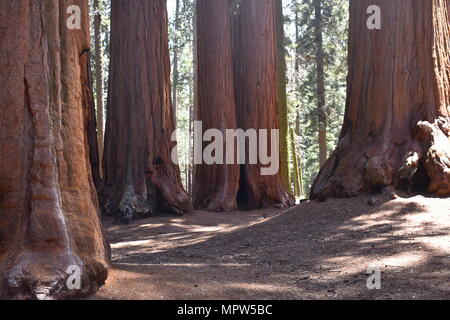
284 0 349 193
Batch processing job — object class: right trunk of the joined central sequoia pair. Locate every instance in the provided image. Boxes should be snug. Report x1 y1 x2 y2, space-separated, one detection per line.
233 0 294 208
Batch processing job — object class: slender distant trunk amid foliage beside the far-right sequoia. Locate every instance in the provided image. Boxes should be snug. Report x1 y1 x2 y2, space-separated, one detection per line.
314 0 328 167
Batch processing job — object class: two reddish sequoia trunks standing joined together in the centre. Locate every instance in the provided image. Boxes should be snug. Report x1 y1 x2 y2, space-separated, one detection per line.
193 0 293 210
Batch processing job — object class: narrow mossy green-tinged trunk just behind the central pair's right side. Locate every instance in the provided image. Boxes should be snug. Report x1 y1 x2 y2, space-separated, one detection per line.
275 0 291 192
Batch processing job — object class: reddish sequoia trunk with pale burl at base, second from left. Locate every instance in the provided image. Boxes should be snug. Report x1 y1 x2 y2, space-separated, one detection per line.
104 0 191 221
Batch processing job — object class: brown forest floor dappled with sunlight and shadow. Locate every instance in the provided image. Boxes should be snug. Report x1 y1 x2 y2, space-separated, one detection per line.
95 195 450 300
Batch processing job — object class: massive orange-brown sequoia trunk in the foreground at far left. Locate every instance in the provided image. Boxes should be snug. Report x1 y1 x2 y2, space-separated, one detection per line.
0 0 108 299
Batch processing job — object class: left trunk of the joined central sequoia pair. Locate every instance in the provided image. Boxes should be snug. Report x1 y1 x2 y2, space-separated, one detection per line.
193 0 239 211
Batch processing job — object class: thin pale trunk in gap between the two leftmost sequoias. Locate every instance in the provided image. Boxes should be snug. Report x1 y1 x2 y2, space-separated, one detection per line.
94 0 105 176
